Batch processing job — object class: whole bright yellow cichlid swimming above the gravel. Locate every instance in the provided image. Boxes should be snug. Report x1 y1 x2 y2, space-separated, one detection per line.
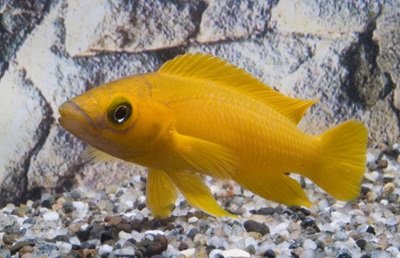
59 53 368 217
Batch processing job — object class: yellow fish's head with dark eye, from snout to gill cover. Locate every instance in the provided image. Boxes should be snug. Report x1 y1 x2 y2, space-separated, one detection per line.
58 76 174 161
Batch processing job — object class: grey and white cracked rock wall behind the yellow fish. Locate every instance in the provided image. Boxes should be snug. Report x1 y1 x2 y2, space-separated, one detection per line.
0 0 400 206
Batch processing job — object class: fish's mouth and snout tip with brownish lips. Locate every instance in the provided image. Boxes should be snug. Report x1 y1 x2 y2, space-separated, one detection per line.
58 100 96 135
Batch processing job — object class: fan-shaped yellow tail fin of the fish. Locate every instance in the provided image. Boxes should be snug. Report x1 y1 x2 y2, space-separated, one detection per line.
307 120 368 201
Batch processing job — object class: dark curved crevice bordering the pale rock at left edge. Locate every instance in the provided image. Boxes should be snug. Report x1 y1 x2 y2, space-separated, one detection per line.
0 74 55 207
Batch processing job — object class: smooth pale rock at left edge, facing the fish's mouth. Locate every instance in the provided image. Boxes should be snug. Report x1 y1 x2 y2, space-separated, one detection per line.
0 63 53 206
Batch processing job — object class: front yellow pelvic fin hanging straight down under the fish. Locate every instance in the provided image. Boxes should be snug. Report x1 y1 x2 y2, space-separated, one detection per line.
146 169 178 218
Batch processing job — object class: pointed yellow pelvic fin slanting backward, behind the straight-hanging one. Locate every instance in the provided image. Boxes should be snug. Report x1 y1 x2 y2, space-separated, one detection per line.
168 171 235 217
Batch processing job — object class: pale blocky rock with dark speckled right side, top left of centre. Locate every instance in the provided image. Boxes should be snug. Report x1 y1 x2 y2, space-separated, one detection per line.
65 0 201 56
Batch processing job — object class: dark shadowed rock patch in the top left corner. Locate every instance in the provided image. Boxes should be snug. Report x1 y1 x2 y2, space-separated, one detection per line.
0 0 53 78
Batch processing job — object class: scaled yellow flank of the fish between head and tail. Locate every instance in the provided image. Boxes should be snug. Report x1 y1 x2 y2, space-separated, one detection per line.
147 73 318 176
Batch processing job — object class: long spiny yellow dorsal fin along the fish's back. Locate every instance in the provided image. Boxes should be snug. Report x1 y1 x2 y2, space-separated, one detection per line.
157 53 316 124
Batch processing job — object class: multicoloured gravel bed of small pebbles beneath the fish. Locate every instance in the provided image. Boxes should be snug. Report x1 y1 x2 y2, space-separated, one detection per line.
0 146 400 258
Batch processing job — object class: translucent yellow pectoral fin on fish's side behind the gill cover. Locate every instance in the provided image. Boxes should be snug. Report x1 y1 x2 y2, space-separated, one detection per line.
173 133 238 180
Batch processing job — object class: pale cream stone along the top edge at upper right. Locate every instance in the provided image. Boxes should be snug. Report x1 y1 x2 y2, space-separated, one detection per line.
272 0 382 38
